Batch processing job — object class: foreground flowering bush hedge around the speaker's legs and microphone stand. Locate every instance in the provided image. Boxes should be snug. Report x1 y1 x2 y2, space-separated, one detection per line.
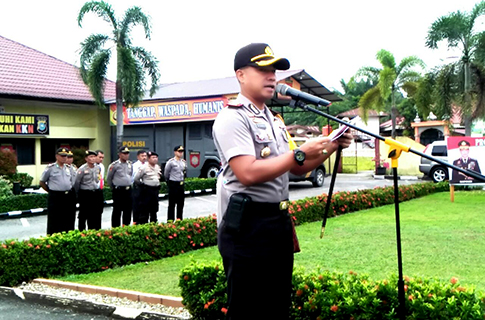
179 262 485 320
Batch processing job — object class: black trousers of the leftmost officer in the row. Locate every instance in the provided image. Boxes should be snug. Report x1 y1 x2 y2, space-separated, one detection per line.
47 190 76 234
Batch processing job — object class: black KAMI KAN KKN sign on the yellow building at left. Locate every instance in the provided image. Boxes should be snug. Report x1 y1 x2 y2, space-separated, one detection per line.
0 113 49 136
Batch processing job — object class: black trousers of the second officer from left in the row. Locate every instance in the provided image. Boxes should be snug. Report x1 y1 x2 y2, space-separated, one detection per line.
78 189 104 231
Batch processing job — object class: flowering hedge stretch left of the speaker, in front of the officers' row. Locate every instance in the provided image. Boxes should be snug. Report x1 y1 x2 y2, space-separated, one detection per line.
0 215 217 286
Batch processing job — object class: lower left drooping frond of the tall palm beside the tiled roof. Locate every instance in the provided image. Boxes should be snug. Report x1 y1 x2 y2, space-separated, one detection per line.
86 50 111 108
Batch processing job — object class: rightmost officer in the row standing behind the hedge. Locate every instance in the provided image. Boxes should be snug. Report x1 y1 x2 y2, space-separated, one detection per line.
163 145 187 220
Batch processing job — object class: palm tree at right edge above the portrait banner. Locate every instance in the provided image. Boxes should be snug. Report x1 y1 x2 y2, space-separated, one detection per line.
426 1 485 136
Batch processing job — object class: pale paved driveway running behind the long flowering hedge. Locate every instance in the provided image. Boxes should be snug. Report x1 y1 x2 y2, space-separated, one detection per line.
0 172 423 241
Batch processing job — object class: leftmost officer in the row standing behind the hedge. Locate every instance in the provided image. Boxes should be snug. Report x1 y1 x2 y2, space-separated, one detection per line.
39 148 76 234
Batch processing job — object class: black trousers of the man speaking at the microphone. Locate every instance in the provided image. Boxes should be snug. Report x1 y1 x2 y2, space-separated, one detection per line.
218 201 293 320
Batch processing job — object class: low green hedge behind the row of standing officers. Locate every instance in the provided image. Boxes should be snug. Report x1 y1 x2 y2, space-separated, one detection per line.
0 178 216 213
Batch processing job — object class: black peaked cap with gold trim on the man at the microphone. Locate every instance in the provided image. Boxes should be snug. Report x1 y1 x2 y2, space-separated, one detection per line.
234 43 290 71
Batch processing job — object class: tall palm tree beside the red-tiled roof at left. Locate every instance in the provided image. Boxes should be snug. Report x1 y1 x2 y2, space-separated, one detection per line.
77 1 159 147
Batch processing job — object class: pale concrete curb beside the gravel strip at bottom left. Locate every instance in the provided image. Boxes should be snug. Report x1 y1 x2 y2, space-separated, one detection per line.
0 279 189 320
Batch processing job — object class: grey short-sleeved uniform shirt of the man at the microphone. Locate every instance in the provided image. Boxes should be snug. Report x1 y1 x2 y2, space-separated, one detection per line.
213 94 290 224
